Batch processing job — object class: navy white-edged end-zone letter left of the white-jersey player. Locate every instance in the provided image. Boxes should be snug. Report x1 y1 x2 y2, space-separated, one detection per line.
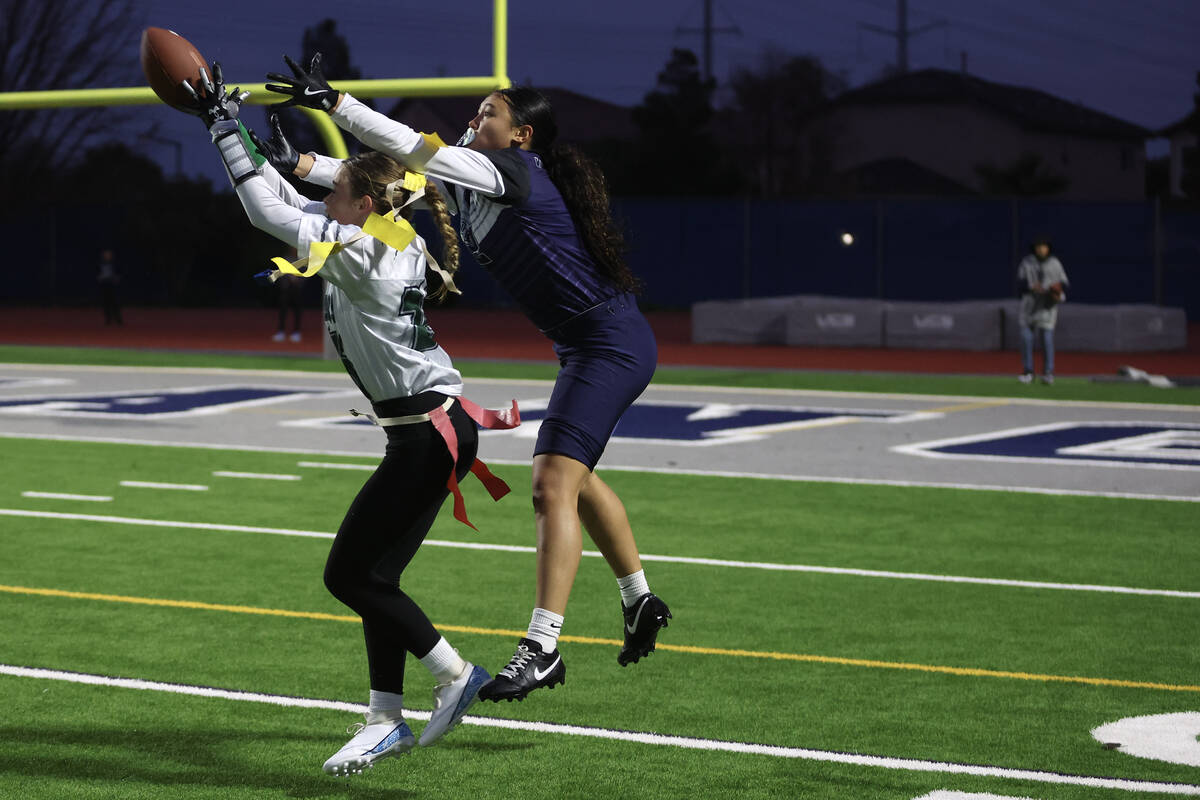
0 384 347 420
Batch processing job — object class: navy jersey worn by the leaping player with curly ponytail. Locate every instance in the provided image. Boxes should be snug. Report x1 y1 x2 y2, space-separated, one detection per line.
448 148 619 338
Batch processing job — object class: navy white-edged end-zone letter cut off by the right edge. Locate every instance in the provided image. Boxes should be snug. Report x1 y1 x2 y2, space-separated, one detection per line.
892 422 1200 469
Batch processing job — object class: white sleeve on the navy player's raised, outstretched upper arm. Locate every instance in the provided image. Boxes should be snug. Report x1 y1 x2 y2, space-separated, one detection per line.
330 95 504 197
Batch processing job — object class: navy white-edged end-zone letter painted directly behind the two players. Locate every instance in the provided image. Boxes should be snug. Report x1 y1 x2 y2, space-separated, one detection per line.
281 398 941 446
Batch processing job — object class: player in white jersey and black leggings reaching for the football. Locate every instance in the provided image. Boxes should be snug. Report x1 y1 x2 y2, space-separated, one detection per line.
193 65 501 775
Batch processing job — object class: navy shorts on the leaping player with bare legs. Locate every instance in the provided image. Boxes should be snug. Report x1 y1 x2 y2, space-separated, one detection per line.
533 294 659 469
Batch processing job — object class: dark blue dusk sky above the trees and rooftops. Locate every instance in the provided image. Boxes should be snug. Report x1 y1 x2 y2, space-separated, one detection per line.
110 0 1200 183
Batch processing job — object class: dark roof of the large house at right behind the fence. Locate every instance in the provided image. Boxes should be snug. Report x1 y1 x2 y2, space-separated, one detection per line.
827 70 1153 139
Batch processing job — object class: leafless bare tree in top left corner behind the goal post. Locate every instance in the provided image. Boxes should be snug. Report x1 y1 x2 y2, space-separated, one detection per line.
0 0 143 195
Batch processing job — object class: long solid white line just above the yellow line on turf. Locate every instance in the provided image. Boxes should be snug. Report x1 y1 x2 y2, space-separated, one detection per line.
0 509 1200 600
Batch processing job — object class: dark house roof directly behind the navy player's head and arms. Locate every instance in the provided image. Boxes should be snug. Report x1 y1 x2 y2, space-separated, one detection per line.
386 88 637 143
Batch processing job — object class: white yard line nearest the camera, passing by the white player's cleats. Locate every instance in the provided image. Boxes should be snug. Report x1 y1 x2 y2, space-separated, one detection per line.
0 664 1200 796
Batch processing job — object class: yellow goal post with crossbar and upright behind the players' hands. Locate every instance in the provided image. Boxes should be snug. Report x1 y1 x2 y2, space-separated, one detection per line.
0 0 512 158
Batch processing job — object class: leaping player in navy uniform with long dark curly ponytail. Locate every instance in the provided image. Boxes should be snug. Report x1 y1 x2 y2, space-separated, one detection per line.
266 54 671 700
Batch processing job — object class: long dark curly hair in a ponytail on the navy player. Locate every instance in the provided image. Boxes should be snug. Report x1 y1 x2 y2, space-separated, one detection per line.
496 86 642 291
